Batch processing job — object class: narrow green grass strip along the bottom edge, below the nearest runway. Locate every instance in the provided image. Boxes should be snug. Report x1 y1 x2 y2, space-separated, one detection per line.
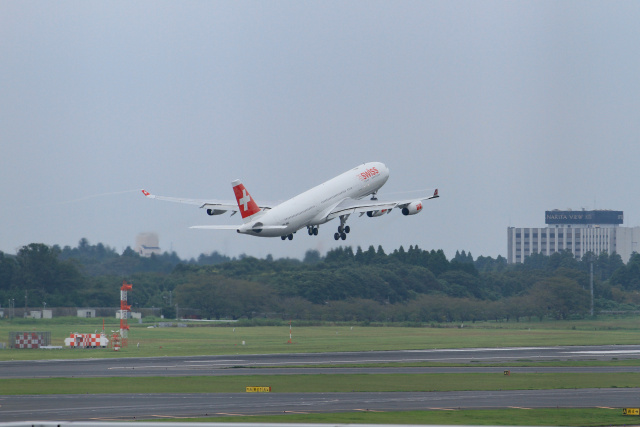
153 408 640 426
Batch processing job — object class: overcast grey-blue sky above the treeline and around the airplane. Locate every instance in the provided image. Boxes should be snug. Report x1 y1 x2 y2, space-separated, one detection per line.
0 0 640 258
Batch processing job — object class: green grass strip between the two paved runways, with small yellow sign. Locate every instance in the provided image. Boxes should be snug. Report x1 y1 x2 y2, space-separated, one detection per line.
0 372 640 395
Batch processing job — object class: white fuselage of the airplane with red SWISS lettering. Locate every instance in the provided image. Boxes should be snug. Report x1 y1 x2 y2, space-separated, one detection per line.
238 162 389 237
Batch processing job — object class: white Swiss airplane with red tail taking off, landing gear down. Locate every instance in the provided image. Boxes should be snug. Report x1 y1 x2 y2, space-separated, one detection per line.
142 162 439 240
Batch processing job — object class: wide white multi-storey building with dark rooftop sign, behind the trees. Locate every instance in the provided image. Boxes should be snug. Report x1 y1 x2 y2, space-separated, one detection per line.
507 210 640 264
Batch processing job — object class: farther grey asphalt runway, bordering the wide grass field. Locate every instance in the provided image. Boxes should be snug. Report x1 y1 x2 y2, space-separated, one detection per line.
0 345 640 378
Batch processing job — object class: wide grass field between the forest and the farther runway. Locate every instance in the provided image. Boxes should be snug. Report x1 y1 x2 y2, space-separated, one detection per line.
0 317 640 360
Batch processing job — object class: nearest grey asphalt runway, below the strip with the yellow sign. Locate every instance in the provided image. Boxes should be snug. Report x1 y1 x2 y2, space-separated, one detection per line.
0 388 640 422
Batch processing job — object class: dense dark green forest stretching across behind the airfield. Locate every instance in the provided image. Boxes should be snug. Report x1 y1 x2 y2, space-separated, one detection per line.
0 239 640 323
